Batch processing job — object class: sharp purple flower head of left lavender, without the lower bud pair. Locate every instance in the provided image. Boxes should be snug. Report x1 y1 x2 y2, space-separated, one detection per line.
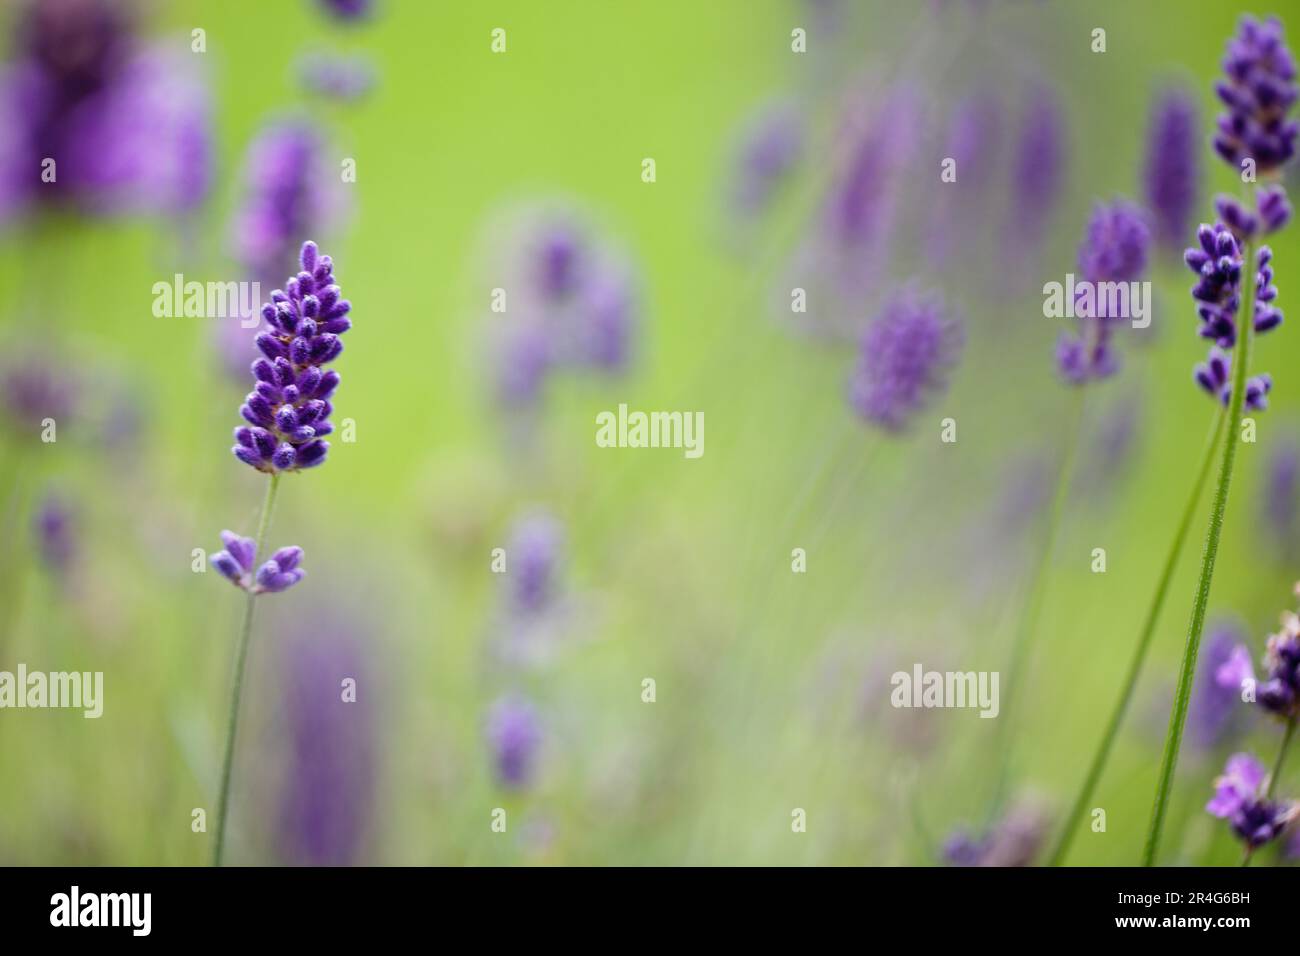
231 242 352 473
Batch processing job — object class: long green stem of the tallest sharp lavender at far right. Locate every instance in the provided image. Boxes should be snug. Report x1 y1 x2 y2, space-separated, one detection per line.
1141 242 1257 866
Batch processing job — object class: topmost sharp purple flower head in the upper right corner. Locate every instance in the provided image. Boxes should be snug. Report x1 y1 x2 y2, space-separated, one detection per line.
1214 17 1300 173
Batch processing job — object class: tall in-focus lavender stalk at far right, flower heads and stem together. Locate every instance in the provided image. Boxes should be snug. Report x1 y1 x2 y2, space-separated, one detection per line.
1141 17 1300 866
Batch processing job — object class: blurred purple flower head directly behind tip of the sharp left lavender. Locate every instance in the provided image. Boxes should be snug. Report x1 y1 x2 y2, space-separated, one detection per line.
234 120 330 282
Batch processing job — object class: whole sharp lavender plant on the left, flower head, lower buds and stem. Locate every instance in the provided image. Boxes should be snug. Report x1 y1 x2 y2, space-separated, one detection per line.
212 241 351 866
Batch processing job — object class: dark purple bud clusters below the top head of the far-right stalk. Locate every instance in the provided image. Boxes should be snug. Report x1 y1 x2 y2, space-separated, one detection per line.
1183 222 1282 411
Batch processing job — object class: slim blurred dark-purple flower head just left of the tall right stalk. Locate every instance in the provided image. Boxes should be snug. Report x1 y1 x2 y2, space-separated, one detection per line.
1143 90 1201 247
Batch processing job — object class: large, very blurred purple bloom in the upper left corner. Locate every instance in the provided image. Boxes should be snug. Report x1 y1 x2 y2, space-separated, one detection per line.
0 0 213 219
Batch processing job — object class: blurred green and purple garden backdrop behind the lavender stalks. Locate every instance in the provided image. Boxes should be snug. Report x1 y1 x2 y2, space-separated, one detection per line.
0 0 1300 865
